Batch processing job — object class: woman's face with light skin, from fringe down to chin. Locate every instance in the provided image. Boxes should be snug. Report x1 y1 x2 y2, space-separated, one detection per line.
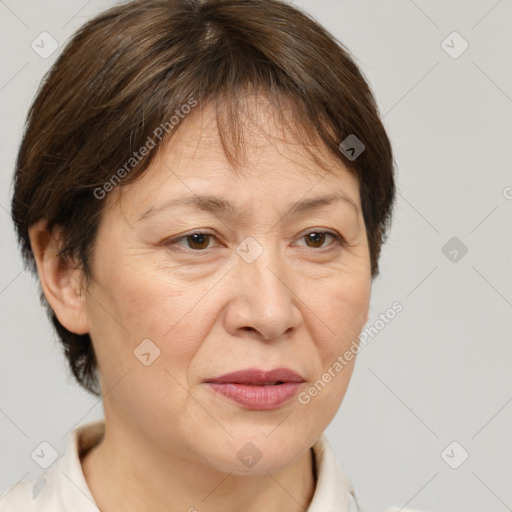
85 98 371 473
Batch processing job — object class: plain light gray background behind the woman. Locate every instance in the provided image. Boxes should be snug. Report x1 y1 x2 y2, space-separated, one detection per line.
0 0 512 511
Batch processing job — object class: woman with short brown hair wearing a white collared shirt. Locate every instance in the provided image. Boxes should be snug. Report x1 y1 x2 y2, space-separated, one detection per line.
0 0 394 512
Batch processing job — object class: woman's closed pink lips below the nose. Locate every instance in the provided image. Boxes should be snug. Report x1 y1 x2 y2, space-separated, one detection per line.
205 368 305 411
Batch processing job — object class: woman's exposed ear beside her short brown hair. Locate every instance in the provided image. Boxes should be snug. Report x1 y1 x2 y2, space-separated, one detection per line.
28 219 89 334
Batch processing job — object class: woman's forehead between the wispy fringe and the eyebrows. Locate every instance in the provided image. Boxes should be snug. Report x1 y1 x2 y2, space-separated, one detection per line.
116 98 360 215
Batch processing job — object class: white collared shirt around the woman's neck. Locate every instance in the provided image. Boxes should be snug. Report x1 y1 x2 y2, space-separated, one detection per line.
0 420 358 512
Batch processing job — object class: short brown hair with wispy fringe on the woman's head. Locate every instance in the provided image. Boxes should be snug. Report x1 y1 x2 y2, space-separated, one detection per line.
12 0 395 395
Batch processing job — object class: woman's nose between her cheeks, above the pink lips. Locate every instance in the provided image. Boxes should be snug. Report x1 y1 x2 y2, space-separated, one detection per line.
224 242 302 341
